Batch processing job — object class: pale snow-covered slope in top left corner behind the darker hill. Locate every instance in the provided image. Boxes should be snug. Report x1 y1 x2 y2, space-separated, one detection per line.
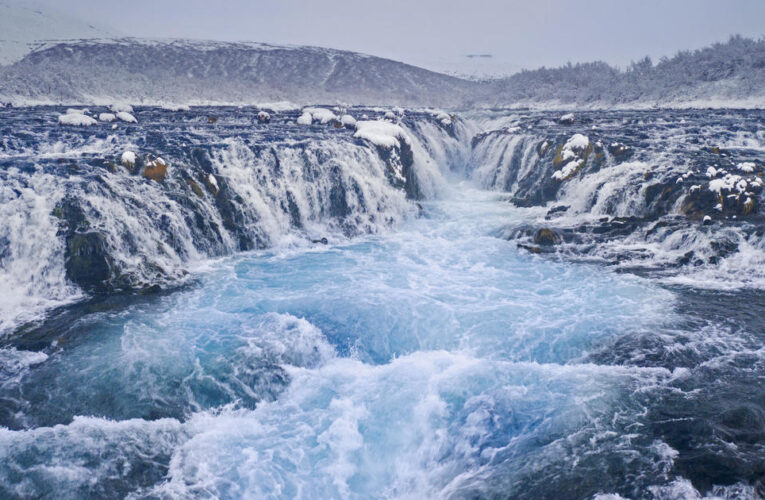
0 0 116 65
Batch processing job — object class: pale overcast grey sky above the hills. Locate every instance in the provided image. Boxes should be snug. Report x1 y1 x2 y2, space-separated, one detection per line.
34 0 765 76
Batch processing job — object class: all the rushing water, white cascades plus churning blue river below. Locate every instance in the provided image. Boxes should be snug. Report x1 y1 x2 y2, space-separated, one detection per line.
0 104 765 498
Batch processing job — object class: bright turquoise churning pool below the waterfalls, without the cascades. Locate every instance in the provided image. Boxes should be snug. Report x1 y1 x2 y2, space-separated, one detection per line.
0 186 674 498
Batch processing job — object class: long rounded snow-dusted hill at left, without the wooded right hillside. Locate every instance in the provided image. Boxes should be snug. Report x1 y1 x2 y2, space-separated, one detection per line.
0 39 478 105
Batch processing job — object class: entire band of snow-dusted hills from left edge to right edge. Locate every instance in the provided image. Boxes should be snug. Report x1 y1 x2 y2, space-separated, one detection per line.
0 37 765 108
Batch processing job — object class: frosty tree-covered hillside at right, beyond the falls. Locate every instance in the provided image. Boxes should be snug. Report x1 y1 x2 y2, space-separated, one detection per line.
486 36 765 107
